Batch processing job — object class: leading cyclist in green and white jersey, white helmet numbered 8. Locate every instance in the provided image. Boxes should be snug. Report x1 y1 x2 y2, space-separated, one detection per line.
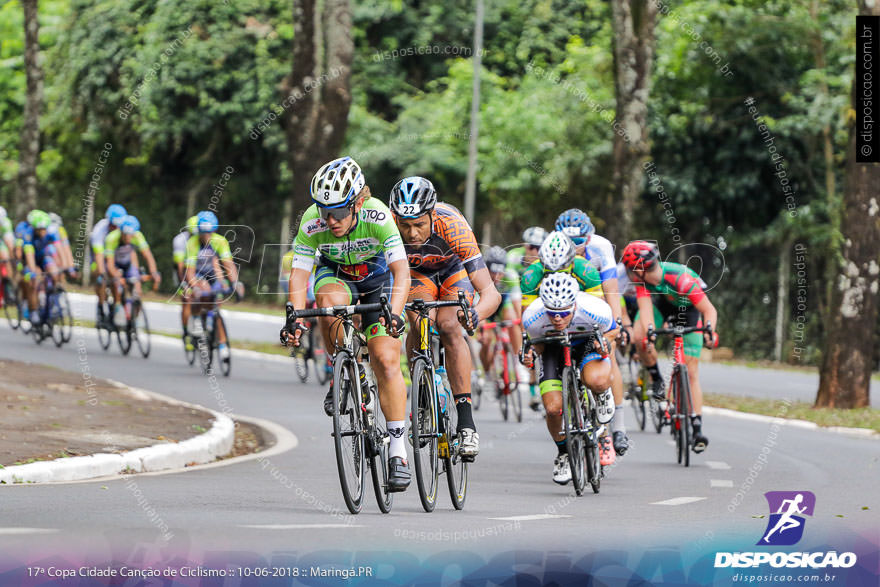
281 157 410 491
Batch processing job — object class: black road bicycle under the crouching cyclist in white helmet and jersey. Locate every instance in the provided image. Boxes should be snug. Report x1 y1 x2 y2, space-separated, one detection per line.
523 325 609 495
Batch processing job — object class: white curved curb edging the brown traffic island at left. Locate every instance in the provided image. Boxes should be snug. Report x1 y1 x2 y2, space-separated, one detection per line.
0 380 235 485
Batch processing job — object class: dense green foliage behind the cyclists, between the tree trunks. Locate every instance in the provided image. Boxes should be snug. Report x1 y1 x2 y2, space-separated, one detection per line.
0 0 868 359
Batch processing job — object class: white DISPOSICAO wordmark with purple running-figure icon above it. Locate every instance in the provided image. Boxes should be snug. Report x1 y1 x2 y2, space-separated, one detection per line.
715 491 857 569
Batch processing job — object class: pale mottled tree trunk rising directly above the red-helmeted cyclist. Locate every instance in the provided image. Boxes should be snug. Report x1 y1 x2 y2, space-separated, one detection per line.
607 0 657 242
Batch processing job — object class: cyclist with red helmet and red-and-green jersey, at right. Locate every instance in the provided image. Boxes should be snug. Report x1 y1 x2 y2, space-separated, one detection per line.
622 241 719 453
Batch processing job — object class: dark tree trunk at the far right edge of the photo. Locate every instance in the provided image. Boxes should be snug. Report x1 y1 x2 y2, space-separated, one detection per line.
816 0 880 408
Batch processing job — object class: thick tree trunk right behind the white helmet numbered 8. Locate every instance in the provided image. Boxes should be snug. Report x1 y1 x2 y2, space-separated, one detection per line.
277 0 354 238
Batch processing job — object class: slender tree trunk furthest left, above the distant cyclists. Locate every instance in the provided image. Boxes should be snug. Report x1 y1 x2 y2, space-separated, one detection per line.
15 0 43 218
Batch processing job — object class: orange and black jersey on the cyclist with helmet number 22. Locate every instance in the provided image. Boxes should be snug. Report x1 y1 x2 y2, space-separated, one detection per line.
404 203 486 274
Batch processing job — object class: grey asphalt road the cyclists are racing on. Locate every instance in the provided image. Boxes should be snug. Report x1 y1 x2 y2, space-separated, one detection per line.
0 322 880 583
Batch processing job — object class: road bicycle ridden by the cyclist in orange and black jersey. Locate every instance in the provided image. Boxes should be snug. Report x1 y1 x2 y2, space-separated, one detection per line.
406 292 473 512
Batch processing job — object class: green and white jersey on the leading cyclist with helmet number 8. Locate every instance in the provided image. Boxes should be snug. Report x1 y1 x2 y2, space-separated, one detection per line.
293 198 406 281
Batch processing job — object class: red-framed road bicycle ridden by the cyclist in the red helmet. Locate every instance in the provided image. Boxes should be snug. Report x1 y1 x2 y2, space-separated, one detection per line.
648 323 712 467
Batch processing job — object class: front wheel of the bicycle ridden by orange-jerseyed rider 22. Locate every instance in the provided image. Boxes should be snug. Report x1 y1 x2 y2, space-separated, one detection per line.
410 357 440 512
